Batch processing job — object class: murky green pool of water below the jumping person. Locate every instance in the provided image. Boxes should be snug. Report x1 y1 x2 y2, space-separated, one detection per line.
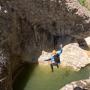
13 64 90 90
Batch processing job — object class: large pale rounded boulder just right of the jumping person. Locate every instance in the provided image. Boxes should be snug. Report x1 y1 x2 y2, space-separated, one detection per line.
61 43 90 70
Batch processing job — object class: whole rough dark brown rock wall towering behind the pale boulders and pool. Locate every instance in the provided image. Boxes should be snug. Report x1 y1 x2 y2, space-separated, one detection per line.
0 0 90 90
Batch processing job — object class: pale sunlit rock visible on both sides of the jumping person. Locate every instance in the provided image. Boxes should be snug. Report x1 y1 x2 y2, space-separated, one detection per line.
38 43 90 71
